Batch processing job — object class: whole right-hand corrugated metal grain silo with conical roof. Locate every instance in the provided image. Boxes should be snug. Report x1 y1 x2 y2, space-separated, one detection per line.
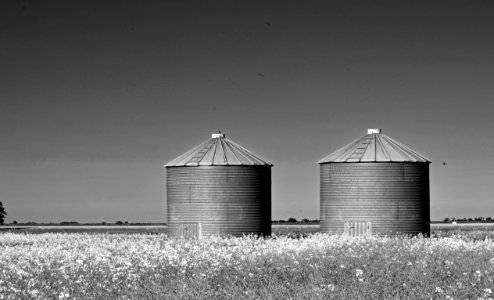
319 129 430 235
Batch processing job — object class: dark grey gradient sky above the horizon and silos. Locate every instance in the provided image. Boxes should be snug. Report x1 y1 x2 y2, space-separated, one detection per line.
0 0 494 222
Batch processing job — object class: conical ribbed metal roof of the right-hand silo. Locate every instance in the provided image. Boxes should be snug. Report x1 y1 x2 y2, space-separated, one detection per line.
319 129 431 164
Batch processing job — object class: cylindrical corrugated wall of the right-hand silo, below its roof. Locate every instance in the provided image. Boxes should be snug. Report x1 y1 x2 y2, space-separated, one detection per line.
320 162 430 235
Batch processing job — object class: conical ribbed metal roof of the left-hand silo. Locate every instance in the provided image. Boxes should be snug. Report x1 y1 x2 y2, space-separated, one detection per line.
165 133 273 167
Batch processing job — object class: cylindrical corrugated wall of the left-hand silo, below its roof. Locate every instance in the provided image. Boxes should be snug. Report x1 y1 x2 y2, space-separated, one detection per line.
166 165 271 236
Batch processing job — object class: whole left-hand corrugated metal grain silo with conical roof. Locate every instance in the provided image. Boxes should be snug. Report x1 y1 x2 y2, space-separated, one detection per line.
165 133 273 236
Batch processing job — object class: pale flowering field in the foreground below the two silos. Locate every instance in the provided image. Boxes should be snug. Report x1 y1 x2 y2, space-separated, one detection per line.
0 233 494 299
